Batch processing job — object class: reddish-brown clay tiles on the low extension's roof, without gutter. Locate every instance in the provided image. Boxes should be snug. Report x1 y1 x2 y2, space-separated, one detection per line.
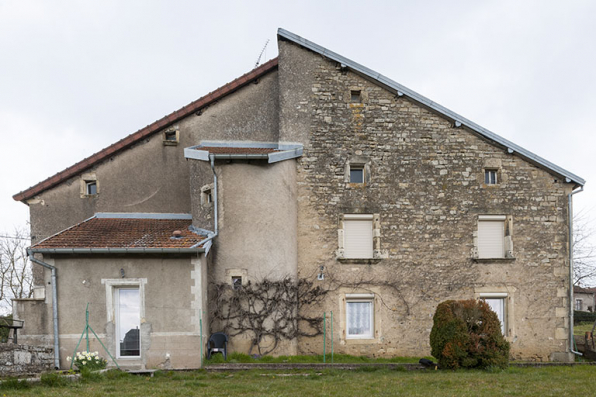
31 218 207 249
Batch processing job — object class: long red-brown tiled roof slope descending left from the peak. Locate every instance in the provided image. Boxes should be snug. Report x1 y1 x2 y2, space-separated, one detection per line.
12 58 277 201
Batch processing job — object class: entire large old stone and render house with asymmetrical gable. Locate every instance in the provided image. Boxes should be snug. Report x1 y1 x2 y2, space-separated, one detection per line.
14 29 584 368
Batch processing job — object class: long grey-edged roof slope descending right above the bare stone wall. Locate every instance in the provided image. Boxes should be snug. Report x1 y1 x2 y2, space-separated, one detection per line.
277 28 586 186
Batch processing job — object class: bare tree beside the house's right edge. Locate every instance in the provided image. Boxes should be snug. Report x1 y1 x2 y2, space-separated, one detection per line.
573 211 596 286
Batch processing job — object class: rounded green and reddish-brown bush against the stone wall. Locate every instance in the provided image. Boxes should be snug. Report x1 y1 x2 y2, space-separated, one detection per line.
430 299 509 369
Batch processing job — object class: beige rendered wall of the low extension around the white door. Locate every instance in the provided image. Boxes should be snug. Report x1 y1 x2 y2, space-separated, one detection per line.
19 255 208 368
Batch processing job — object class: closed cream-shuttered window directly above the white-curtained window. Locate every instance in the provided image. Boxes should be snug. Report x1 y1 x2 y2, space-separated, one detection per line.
343 214 373 259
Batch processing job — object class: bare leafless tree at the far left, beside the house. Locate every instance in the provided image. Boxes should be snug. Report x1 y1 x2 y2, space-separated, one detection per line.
0 229 33 314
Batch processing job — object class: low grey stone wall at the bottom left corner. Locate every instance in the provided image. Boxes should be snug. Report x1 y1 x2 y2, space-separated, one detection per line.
0 343 54 377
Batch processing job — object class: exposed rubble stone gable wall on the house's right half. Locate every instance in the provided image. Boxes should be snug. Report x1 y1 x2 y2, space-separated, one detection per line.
280 42 572 360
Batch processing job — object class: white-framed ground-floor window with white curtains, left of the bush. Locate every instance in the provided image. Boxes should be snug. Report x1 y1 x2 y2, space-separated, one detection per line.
346 294 374 339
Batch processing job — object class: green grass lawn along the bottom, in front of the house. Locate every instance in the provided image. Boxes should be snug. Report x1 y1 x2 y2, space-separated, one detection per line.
0 366 596 397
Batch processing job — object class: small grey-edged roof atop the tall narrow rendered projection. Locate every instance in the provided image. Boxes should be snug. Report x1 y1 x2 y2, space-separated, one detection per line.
184 141 303 163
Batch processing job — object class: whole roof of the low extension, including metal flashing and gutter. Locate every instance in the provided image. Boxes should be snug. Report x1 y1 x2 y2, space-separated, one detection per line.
31 213 207 253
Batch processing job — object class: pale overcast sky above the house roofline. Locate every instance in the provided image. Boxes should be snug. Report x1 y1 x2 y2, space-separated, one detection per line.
0 0 596 256
